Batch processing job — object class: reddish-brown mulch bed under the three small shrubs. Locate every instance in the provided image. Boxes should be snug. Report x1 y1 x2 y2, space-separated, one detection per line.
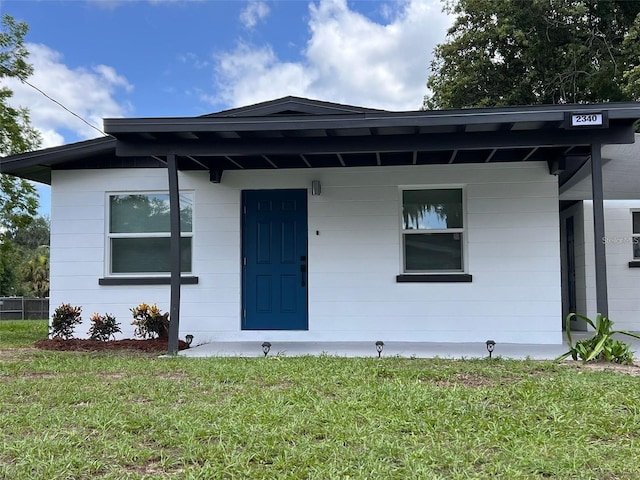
34 338 189 353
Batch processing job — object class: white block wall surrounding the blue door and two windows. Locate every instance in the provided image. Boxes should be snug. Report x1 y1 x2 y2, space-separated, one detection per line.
51 162 562 344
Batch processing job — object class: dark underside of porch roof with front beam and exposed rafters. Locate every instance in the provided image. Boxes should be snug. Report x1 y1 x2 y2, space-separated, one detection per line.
111 124 590 170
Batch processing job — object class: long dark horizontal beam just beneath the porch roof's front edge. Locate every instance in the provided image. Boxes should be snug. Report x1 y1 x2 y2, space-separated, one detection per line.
116 126 634 156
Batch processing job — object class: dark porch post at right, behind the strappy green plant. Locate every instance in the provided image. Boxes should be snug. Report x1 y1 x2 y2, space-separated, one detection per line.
591 143 609 317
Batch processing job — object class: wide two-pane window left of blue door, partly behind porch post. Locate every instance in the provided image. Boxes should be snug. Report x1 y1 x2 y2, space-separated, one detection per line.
108 193 193 275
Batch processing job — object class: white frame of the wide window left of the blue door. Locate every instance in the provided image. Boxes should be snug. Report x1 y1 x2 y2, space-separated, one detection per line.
105 190 195 278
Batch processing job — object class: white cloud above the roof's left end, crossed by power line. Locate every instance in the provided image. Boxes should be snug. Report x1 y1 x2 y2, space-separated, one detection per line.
7 43 133 148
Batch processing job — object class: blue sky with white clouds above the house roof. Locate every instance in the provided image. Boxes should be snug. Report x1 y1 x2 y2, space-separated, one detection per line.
0 0 451 214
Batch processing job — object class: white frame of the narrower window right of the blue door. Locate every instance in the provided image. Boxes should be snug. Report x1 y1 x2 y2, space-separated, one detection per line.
398 184 468 275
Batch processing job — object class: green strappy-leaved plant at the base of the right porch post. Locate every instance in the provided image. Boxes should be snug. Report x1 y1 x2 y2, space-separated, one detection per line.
557 313 640 364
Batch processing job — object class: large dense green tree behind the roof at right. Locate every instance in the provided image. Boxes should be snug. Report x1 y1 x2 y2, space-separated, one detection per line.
424 0 640 109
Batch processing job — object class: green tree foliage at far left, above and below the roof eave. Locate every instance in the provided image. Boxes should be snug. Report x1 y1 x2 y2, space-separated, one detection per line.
0 15 41 295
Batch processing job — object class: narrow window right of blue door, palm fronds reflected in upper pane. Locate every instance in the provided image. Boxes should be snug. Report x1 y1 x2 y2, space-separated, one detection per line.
402 188 465 273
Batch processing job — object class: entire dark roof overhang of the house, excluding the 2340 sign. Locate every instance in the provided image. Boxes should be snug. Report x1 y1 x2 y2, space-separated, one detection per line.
2 97 640 188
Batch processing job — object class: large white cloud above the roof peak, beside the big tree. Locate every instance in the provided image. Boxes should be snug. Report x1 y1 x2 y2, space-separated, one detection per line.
207 0 451 110
